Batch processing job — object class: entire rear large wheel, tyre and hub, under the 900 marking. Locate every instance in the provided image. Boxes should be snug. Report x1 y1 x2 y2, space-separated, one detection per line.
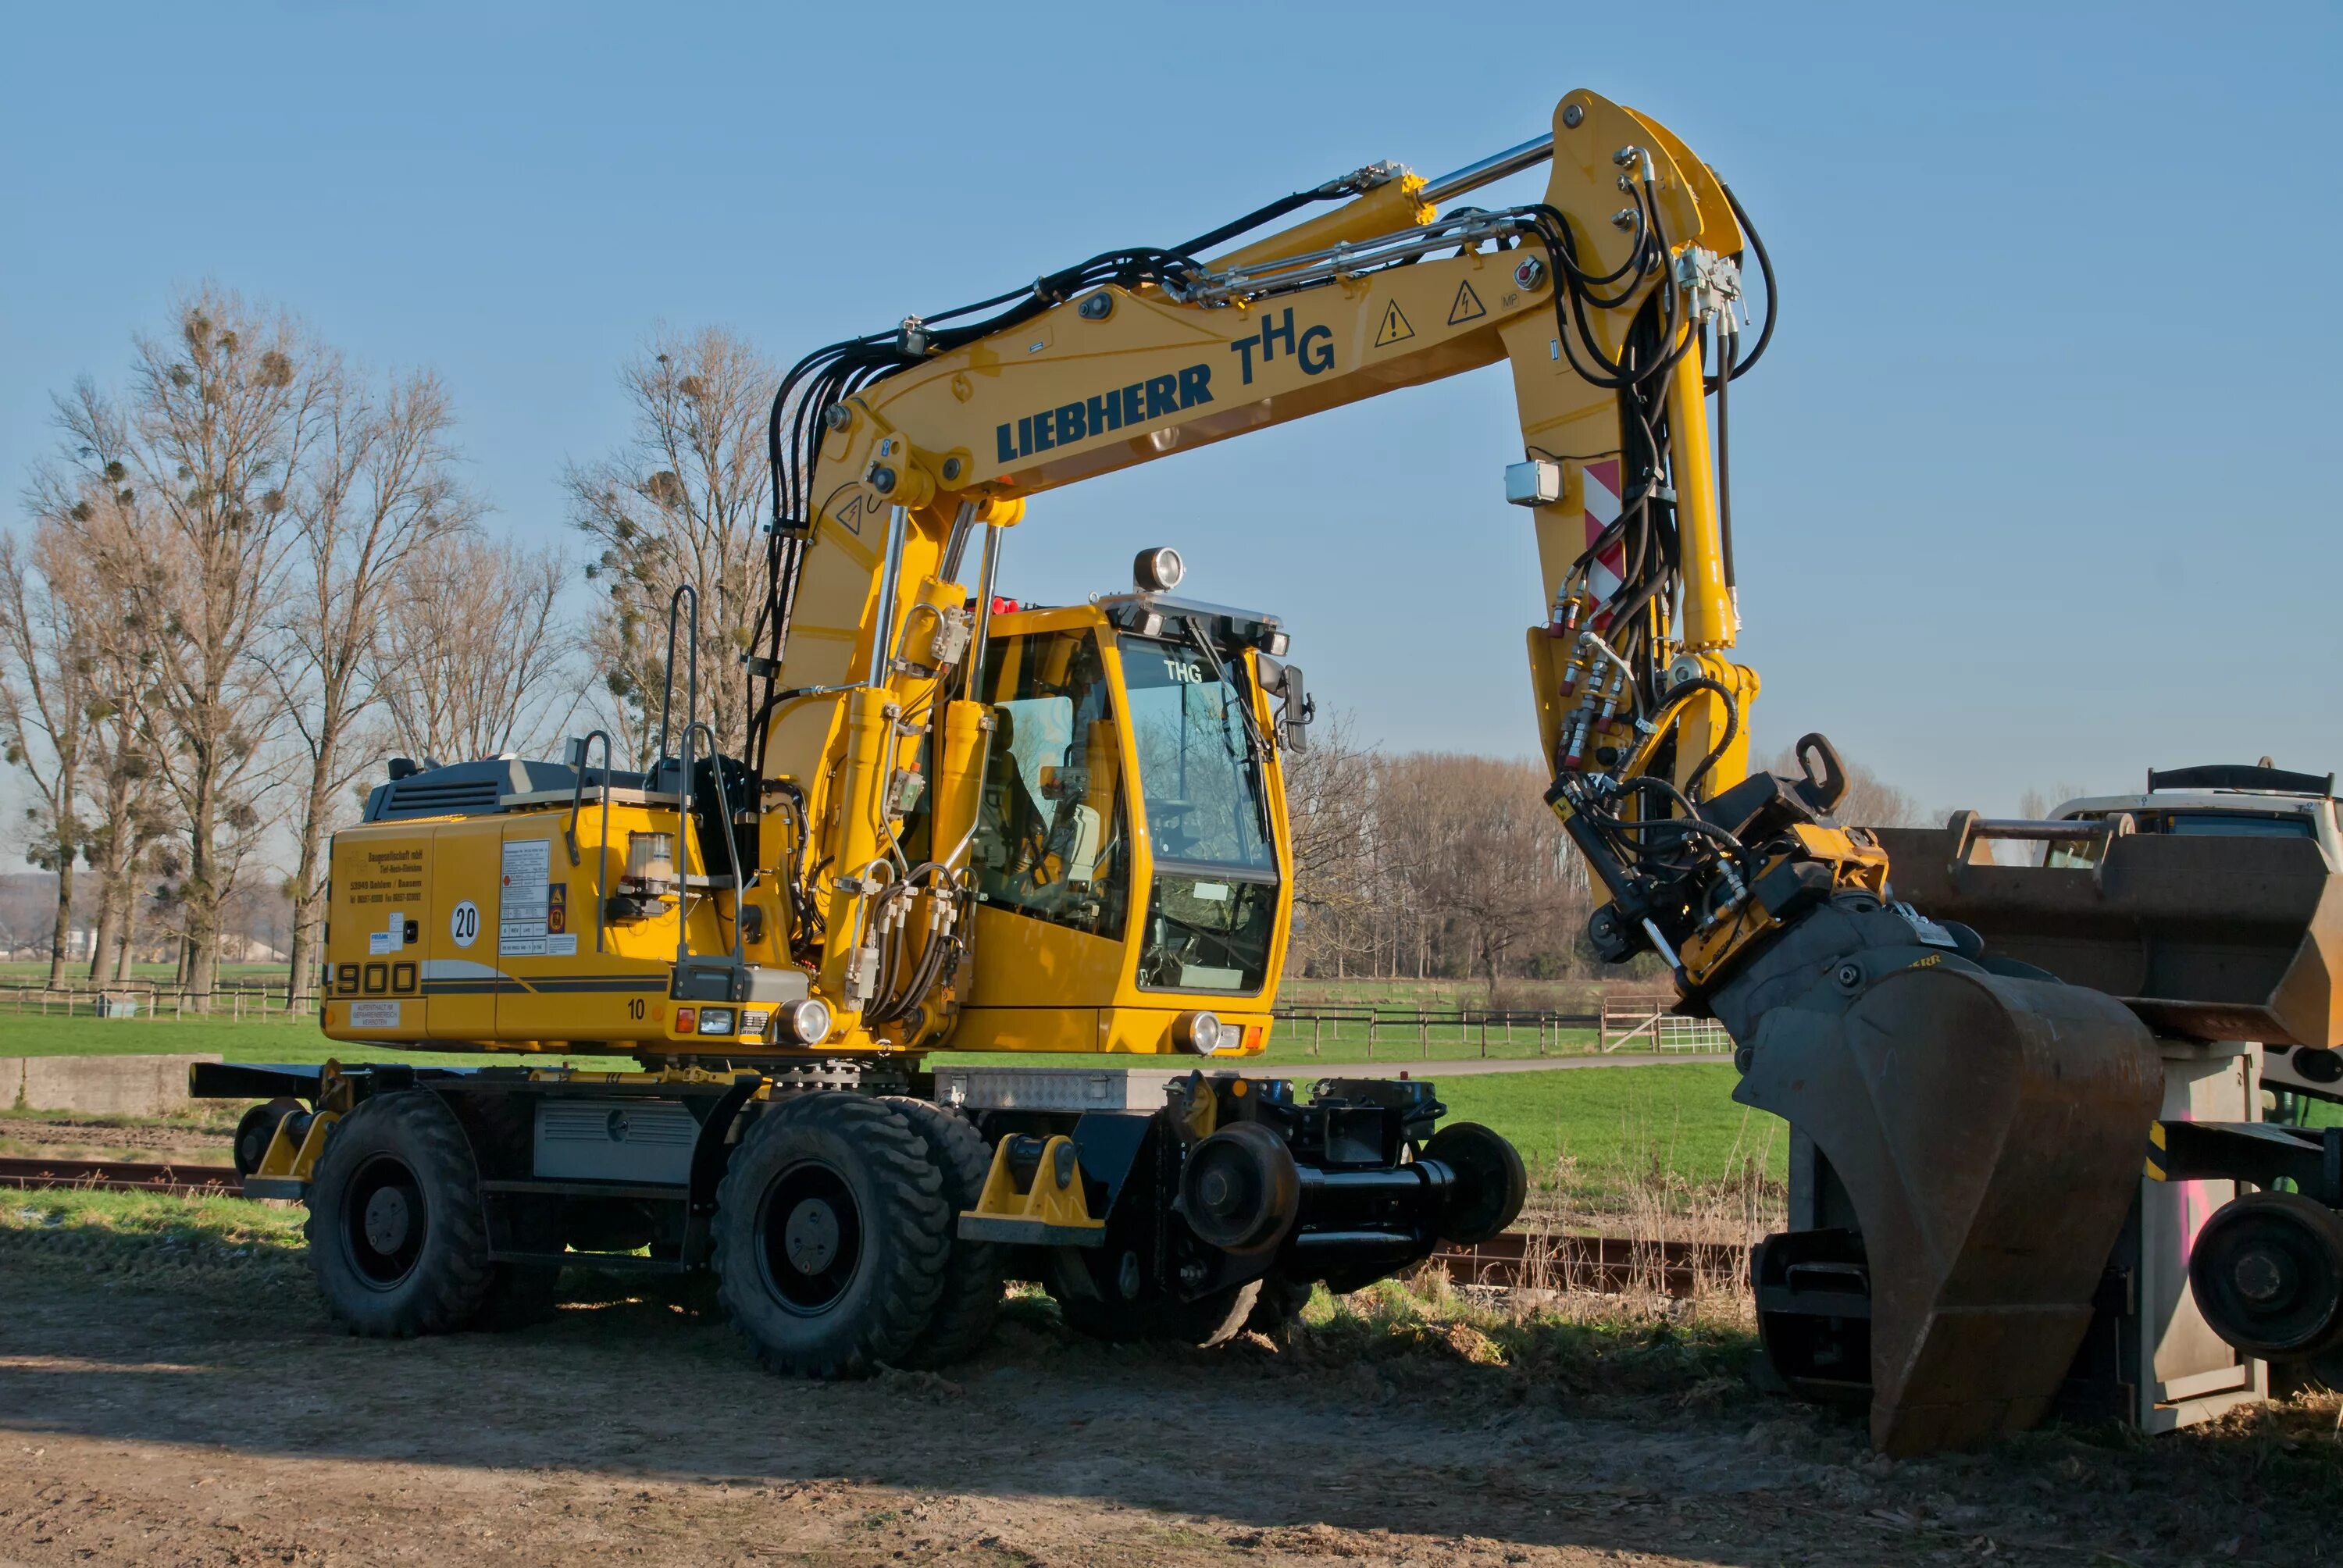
307 1090 492 1338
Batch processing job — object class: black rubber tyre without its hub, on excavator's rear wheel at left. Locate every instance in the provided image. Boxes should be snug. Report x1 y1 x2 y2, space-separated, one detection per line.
302 1090 490 1338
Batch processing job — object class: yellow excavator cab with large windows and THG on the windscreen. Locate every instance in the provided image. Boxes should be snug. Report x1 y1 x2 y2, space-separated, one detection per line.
951 590 1307 1055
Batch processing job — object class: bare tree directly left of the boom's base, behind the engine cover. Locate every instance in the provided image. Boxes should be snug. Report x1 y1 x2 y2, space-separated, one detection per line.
562 328 780 757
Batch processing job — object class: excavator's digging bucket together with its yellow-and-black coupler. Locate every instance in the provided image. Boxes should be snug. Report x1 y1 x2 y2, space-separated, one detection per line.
1556 736 2163 1453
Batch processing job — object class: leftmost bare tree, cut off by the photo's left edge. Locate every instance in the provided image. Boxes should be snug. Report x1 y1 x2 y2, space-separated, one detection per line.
0 518 96 987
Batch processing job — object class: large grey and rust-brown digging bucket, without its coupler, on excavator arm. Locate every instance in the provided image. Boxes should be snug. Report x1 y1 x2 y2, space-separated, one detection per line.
1734 954 2163 1456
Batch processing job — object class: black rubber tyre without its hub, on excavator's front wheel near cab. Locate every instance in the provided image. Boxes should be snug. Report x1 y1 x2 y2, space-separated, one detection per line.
715 1090 951 1378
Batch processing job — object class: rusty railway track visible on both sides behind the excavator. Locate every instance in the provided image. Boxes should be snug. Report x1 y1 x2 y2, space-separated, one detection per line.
0 1156 1748 1299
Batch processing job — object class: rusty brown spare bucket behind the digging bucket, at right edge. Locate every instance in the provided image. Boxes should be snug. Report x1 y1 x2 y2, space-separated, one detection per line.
1877 811 2343 1048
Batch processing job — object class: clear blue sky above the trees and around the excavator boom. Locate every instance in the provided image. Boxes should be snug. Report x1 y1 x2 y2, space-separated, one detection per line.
0 5 2343 829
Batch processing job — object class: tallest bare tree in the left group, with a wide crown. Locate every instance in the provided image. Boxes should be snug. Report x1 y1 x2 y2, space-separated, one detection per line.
59 286 340 1006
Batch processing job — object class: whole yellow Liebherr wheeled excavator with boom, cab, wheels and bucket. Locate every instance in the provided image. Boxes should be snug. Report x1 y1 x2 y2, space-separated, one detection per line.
197 91 2343 1451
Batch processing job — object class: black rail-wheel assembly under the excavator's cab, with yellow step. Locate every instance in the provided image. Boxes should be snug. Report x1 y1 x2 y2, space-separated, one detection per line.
937 1069 1528 1313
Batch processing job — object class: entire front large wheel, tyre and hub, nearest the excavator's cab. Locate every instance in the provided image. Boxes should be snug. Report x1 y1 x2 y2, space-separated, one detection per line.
715 1092 951 1378
